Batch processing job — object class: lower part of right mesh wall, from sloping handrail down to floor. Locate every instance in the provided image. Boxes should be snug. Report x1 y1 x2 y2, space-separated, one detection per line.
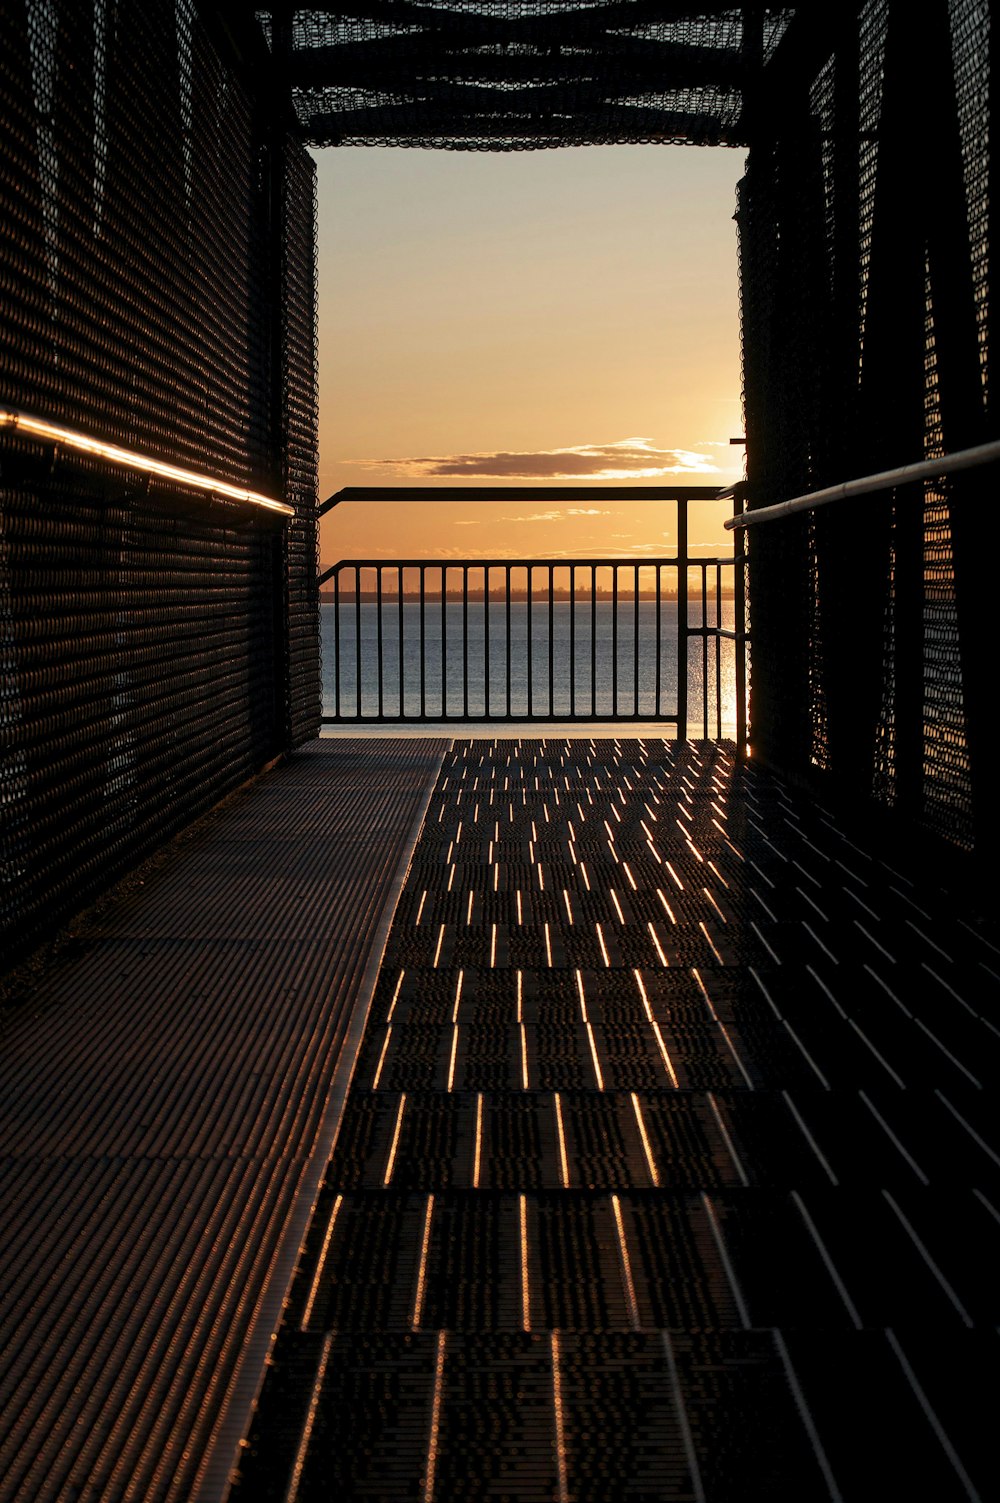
725 440 1000 860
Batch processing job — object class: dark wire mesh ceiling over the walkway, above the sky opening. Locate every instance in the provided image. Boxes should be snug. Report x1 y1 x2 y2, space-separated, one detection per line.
262 0 792 150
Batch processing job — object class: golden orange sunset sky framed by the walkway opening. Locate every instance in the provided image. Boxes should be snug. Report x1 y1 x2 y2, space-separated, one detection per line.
316 146 743 564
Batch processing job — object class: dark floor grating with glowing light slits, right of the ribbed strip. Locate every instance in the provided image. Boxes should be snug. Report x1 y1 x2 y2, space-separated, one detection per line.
233 739 1000 1503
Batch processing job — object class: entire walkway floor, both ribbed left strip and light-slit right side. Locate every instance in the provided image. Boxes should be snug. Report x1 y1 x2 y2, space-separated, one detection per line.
0 726 1000 1503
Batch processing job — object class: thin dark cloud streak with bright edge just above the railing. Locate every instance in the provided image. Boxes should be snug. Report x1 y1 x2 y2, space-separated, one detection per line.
344 437 719 477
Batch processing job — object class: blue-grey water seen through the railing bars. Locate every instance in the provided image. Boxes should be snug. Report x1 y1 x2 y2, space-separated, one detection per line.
322 600 735 736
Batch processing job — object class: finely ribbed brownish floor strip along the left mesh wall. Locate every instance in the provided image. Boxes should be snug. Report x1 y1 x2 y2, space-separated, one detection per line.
0 739 448 1503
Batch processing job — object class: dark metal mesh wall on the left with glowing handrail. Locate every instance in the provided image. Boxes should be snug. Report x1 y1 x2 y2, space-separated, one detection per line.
0 0 319 957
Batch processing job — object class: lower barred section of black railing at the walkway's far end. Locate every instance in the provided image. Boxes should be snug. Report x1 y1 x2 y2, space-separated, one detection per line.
322 555 743 738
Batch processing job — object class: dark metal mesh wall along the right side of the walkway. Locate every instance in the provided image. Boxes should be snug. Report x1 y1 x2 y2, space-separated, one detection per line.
738 0 997 849
